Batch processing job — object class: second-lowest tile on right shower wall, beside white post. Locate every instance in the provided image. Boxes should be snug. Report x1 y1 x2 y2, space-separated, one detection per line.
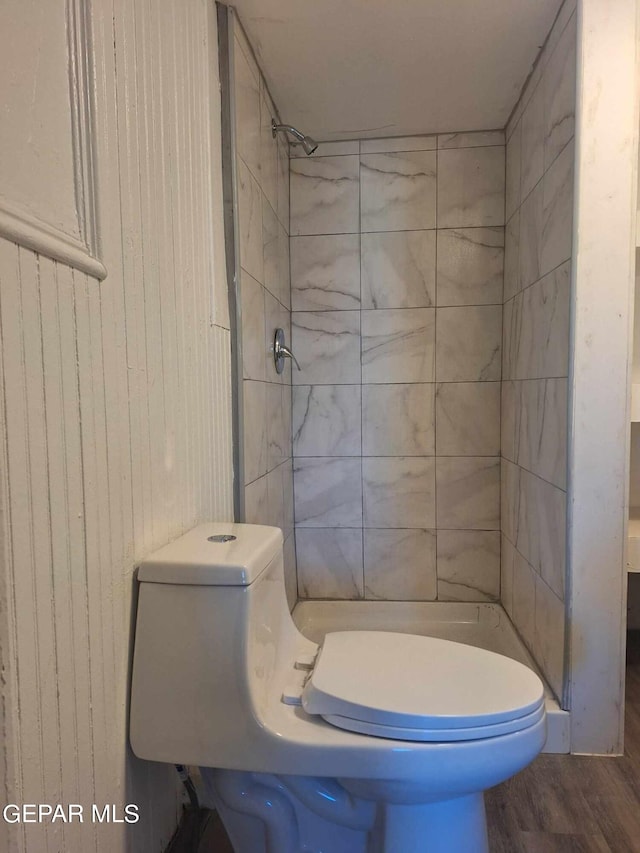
514 470 567 600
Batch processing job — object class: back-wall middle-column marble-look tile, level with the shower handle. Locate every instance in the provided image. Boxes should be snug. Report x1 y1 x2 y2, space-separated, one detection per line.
362 308 438 383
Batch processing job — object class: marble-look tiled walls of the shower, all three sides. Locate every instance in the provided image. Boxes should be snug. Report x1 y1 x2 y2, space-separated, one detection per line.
228 2 575 697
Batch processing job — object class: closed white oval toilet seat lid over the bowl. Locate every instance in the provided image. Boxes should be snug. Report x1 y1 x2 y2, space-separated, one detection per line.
302 631 544 740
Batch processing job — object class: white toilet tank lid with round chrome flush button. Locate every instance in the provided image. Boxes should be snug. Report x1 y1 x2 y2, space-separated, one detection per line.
138 522 282 586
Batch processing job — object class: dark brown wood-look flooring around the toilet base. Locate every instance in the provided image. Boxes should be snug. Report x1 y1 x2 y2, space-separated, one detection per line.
175 631 640 853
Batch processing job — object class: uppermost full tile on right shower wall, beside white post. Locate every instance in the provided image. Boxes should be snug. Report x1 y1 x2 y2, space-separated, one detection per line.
543 14 576 169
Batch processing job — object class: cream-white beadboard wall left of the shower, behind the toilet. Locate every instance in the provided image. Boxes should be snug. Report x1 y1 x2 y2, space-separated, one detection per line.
0 0 232 853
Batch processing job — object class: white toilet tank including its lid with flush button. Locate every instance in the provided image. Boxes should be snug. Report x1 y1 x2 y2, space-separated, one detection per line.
129 523 288 766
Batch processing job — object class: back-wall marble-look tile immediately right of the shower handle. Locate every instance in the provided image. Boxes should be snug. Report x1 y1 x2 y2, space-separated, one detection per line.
292 311 361 385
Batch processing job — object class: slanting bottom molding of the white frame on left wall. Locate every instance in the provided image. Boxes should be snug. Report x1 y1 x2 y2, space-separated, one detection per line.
0 198 107 280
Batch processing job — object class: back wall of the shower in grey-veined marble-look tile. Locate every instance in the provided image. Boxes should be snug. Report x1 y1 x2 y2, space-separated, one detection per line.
291 132 505 600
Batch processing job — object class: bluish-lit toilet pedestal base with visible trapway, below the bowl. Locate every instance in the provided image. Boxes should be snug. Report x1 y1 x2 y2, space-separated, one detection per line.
201 768 489 853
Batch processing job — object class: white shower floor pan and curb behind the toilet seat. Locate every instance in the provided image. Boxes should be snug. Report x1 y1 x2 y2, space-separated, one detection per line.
293 601 569 753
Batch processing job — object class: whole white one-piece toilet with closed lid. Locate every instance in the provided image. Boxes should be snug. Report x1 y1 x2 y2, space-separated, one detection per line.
130 523 546 853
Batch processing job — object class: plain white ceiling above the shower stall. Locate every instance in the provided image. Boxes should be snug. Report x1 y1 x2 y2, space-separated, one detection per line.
235 0 561 140
